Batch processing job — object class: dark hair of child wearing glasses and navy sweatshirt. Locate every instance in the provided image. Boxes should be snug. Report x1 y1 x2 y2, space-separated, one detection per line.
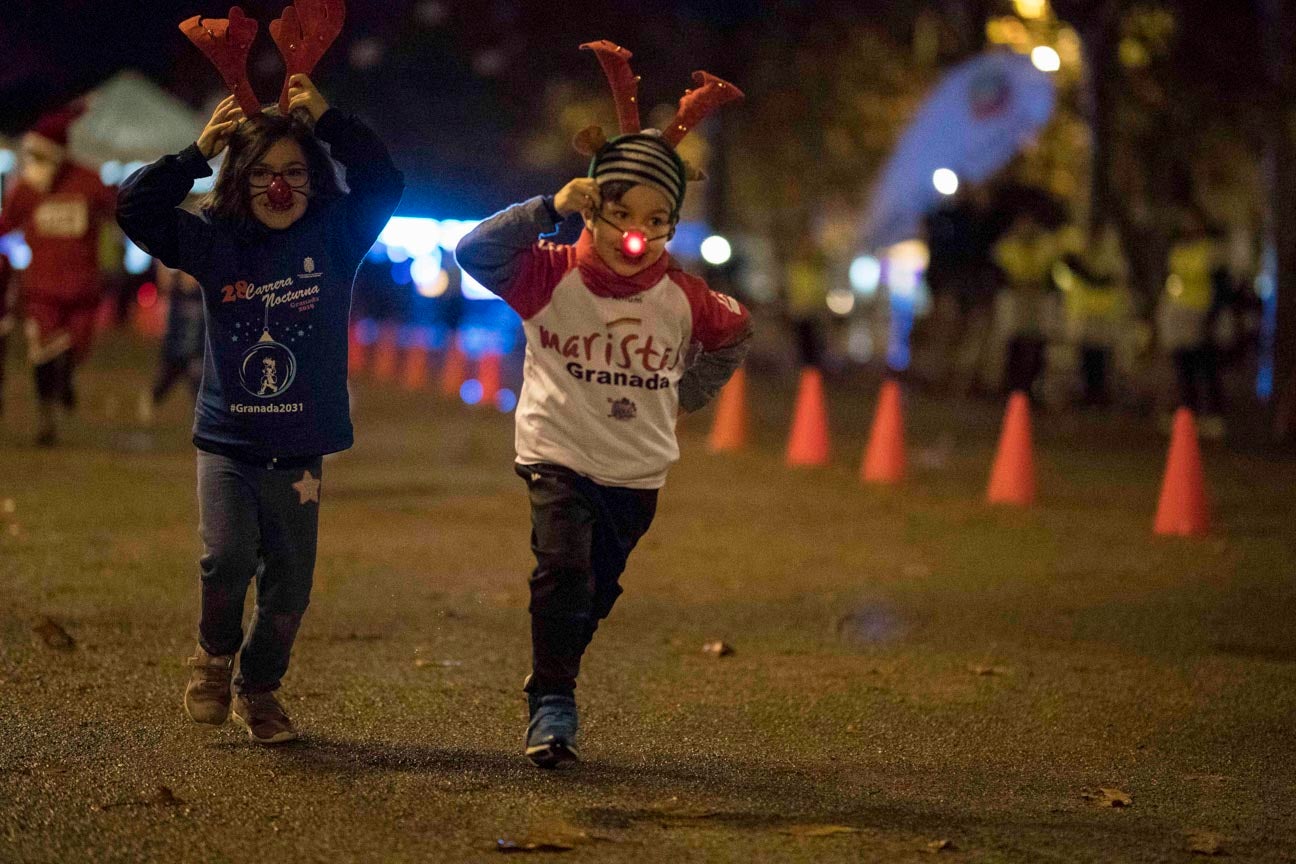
200 108 345 232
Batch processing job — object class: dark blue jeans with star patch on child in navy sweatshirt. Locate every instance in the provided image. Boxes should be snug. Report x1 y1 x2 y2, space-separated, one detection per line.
198 449 323 693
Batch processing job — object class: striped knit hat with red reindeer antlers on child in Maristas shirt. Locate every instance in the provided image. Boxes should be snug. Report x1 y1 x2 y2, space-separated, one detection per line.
574 39 743 218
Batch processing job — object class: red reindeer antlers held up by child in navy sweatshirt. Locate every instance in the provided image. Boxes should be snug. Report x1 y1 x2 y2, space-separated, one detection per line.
180 0 346 117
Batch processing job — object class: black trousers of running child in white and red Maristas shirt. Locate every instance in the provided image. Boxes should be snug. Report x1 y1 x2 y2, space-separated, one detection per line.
516 465 657 696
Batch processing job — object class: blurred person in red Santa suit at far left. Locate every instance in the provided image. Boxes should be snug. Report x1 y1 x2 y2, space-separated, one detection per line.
0 105 117 447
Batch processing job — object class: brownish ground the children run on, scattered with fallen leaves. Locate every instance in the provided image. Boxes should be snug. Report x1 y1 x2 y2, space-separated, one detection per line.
0 341 1296 863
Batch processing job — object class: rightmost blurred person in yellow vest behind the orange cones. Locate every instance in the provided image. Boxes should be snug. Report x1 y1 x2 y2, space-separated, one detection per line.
1157 209 1232 439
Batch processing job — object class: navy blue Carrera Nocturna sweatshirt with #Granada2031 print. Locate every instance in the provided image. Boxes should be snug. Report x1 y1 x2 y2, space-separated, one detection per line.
117 109 404 461
